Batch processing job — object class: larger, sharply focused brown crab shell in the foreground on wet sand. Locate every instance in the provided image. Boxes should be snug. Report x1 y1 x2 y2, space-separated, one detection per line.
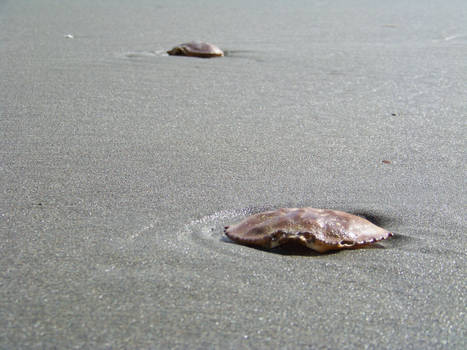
224 207 392 253
